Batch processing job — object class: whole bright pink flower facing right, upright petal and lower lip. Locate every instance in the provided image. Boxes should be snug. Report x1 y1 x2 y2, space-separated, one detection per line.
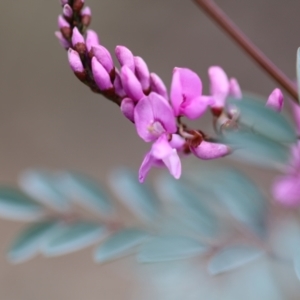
171 68 210 119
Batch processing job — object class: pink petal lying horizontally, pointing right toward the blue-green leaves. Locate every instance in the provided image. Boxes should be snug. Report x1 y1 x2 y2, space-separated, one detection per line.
191 141 230 160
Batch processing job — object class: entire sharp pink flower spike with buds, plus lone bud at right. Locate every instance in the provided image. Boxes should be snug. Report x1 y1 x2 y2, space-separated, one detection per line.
56 0 282 182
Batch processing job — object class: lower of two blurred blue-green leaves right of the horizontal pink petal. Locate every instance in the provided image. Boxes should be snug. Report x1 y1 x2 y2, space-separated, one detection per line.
223 131 290 168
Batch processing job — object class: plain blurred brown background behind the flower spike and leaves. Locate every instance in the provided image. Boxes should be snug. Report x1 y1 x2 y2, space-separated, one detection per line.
0 0 300 300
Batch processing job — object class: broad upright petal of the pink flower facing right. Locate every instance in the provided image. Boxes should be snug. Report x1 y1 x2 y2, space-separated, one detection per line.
171 68 202 116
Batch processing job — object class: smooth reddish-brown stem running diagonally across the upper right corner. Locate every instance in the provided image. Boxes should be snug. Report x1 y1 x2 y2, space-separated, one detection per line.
194 0 299 103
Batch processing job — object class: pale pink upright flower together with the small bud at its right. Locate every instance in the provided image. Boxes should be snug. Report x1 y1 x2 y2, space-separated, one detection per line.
208 66 242 108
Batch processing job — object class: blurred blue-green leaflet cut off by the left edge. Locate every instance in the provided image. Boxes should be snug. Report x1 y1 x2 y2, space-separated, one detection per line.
0 187 45 221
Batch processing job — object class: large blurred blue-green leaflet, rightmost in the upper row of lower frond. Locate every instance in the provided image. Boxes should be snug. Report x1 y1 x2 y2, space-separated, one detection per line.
191 168 267 237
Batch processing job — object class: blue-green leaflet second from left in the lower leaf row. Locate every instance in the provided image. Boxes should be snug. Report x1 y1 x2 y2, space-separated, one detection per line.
42 222 107 256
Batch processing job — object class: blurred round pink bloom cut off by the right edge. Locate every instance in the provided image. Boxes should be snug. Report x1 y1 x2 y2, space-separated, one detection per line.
272 175 300 207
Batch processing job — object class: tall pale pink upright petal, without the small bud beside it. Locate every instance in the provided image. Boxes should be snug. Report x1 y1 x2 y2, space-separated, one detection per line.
208 66 229 108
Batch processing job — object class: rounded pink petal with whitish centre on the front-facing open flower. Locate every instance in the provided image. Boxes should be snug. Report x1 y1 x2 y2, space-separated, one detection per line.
134 93 177 142
